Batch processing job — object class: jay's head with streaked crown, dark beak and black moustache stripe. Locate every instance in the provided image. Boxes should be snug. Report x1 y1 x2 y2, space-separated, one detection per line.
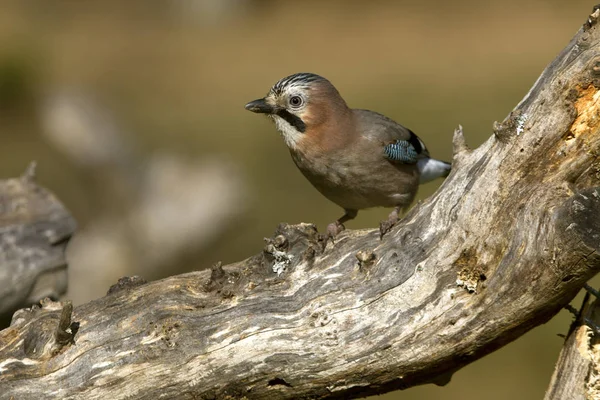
246 73 349 149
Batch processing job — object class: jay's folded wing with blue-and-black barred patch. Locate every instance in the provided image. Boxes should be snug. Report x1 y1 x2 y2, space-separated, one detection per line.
354 110 429 164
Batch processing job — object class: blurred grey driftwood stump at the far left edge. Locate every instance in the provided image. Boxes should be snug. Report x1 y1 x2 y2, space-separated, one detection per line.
0 163 75 328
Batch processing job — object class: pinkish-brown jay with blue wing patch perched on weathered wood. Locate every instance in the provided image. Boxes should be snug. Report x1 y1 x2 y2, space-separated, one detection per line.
245 72 451 240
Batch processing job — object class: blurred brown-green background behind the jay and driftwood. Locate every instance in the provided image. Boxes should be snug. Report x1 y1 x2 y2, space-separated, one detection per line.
0 0 600 400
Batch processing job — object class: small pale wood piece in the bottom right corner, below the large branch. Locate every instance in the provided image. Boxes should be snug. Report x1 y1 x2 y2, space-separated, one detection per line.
544 295 600 400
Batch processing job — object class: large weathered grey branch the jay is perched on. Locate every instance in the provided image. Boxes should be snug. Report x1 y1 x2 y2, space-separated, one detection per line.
0 7 600 399
